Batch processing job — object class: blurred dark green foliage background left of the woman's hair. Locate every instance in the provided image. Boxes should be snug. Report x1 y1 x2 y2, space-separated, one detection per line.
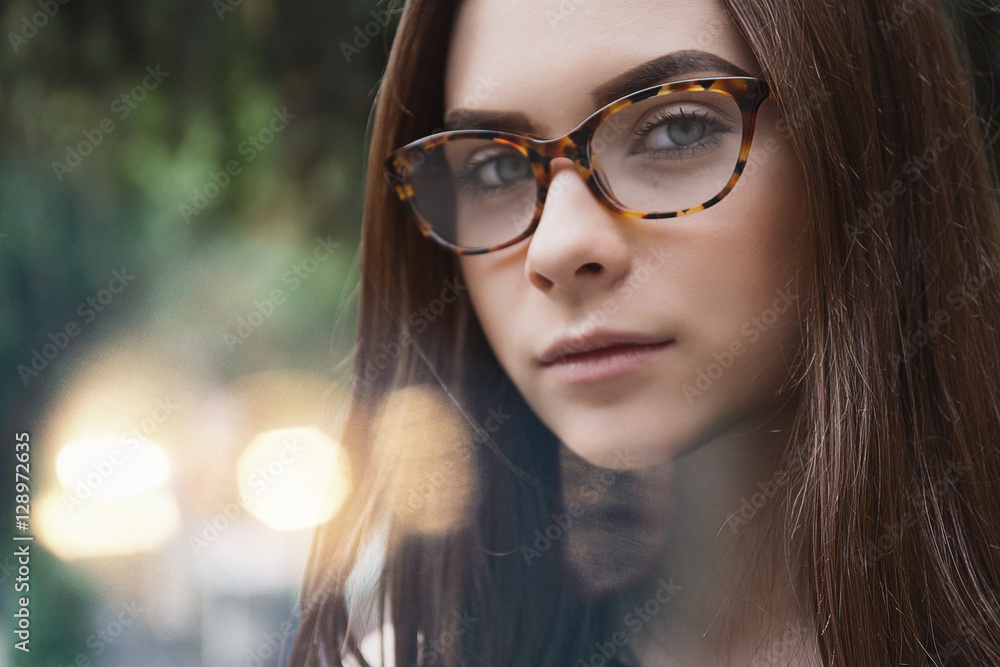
0 0 392 665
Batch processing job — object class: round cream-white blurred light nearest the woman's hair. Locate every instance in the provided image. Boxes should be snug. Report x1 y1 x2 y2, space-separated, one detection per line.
236 428 351 530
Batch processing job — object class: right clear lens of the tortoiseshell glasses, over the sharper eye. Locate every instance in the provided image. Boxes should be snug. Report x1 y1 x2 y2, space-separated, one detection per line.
590 91 743 213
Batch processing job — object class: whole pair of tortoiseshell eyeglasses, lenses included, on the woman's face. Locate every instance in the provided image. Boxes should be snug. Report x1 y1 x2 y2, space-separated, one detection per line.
386 77 770 255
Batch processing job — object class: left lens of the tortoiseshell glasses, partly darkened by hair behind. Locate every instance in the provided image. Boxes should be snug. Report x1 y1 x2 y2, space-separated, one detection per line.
410 137 537 248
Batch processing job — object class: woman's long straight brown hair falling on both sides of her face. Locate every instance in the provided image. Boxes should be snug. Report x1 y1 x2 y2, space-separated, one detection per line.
292 0 1000 667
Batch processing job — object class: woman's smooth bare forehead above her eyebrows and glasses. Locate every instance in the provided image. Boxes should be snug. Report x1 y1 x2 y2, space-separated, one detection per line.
445 0 757 136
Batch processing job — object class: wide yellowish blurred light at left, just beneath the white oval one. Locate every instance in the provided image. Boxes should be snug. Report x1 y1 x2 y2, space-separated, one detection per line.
38 490 180 560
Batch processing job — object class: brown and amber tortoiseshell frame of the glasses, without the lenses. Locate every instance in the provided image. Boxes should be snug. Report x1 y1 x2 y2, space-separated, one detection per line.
385 76 770 255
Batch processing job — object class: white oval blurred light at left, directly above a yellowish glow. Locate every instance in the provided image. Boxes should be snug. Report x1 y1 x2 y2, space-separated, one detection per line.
56 435 170 501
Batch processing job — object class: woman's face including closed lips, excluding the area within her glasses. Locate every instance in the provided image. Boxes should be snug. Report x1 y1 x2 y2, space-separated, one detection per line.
445 0 807 467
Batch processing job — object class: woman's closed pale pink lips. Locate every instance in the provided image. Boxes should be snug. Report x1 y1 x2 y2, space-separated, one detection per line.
538 330 674 383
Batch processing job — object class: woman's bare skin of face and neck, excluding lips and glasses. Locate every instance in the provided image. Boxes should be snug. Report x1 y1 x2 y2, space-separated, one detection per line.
445 0 812 667
